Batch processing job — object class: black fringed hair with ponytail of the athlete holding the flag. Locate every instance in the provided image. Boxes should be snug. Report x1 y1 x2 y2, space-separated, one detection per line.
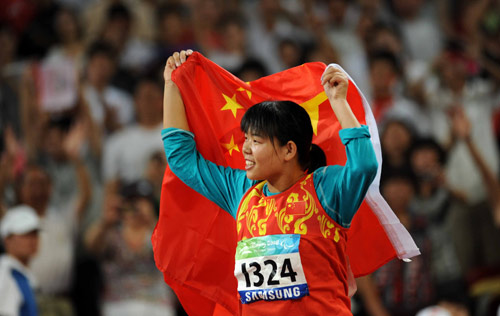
240 101 326 173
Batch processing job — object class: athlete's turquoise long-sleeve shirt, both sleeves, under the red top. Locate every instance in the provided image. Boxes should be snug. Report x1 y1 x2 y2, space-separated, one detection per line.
161 125 378 228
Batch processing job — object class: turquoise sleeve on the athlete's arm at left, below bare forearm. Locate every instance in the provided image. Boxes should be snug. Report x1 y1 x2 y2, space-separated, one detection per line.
161 128 254 218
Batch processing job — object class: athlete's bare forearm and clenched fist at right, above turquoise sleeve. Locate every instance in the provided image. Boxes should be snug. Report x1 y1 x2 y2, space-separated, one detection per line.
321 66 361 128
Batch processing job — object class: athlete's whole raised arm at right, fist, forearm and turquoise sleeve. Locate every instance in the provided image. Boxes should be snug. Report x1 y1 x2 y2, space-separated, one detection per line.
314 66 378 227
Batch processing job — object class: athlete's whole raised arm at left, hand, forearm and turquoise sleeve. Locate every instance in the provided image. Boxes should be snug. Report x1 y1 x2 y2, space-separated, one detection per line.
162 50 253 217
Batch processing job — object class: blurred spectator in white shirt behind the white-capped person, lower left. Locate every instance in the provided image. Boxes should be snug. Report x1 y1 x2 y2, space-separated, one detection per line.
18 165 83 316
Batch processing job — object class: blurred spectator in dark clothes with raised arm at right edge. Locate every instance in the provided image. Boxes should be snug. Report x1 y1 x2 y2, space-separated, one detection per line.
450 108 500 315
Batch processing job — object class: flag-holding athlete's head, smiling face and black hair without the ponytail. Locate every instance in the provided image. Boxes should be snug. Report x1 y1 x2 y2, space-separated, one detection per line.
240 101 313 185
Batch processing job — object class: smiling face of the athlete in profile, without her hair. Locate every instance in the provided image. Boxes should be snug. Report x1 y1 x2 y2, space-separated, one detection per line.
243 132 285 182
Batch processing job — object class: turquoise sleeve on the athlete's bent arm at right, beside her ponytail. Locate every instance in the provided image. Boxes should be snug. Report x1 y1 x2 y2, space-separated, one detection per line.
313 125 378 228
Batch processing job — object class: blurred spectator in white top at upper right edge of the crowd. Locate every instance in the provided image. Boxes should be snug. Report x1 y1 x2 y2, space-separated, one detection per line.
425 45 499 205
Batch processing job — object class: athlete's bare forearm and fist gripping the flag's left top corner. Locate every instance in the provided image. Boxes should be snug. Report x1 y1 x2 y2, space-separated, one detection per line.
163 49 193 131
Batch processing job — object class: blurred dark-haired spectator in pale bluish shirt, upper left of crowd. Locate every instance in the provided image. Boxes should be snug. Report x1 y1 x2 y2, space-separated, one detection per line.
83 42 134 136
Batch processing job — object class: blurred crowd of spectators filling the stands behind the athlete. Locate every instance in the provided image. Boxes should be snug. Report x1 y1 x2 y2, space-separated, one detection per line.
0 0 500 316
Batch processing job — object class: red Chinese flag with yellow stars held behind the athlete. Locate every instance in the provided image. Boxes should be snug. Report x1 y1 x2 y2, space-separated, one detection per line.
152 53 419 316
